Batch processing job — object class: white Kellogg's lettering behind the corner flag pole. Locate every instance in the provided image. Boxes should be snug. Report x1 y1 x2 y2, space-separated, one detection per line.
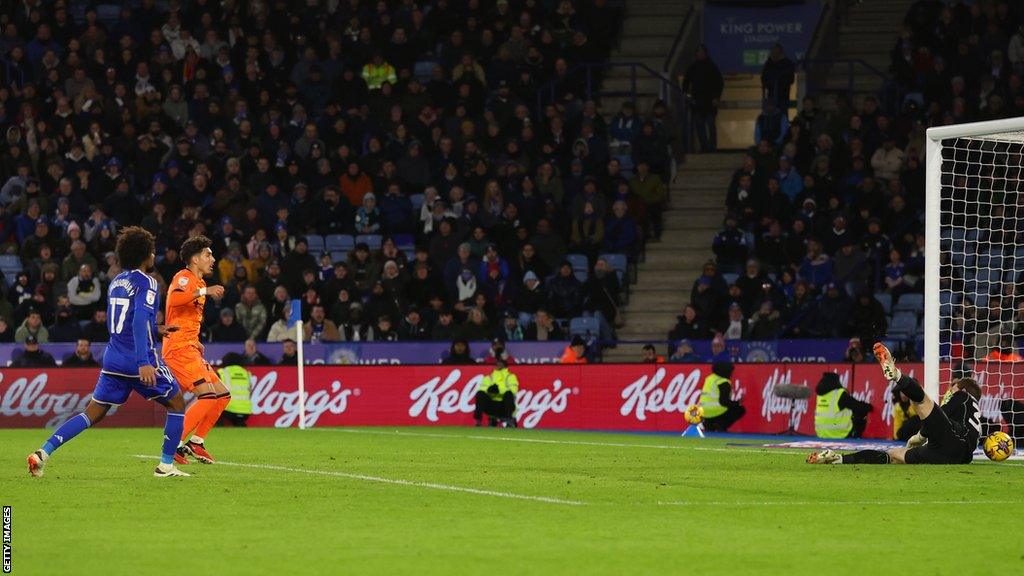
251 370 359 428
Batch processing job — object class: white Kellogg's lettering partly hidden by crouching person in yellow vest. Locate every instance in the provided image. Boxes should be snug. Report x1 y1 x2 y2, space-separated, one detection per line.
409 369 574 428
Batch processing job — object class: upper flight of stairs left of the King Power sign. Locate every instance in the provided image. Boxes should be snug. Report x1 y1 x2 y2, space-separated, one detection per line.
601 0 694 118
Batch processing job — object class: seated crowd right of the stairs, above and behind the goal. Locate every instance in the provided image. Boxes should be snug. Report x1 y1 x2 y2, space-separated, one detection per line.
669 0 1024 357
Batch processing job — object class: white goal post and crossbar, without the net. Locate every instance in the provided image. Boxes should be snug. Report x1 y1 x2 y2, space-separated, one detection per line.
923 117 1024 400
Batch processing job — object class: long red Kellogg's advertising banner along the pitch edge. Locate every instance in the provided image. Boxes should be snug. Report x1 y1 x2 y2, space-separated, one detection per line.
0 364 1007 438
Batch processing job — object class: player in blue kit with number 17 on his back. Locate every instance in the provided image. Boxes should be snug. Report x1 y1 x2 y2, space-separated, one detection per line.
29 227 189 478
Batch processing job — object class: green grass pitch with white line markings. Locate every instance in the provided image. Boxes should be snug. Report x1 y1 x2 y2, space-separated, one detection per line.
0 428 1024 575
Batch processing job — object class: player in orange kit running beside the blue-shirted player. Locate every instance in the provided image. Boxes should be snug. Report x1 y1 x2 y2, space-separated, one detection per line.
163 236 231 464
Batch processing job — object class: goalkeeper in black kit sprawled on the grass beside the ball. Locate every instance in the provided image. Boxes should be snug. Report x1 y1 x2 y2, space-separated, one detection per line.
807 342 981 464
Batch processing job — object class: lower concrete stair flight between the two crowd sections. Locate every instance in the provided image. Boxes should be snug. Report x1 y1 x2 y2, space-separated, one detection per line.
603 152 742 362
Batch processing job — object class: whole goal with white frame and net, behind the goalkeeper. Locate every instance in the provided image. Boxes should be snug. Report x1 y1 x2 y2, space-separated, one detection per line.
925 118 1024 438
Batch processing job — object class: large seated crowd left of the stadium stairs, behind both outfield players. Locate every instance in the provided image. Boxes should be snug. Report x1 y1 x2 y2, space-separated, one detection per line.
0 0 670 352
